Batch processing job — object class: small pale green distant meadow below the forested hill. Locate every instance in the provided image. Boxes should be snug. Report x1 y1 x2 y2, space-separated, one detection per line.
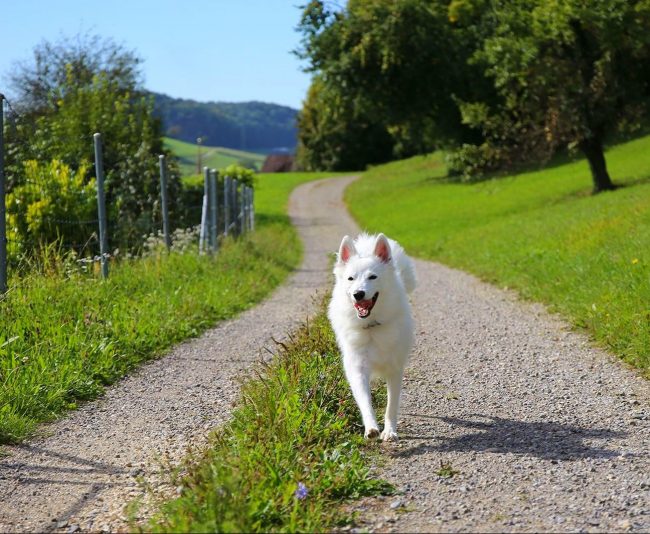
165 137 265 176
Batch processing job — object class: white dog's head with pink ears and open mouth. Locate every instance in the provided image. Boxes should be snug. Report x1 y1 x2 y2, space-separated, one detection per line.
334 234 392 319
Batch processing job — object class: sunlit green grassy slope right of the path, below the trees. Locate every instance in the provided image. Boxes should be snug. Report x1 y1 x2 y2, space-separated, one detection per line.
346 136 650 373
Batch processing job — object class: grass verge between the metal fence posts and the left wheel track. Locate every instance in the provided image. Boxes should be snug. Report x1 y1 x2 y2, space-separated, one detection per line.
0 173 330 443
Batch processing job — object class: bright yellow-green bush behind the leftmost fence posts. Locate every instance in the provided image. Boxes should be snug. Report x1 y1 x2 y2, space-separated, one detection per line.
7 159 97 256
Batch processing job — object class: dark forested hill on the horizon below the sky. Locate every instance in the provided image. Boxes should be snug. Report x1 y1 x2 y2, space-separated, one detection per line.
151 93 298 153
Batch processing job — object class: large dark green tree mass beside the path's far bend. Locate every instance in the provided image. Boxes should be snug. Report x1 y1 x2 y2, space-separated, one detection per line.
298 0 482 169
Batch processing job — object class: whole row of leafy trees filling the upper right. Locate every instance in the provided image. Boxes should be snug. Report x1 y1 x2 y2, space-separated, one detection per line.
298 0 650 186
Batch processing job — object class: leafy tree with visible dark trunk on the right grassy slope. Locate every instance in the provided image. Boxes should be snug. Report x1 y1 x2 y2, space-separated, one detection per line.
450 0 650 193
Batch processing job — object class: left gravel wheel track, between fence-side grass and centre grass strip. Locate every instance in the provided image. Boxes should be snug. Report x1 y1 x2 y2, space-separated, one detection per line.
0 177 354 532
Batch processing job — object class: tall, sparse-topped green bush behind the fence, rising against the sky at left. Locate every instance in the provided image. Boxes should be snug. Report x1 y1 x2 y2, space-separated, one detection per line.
6 34 180 255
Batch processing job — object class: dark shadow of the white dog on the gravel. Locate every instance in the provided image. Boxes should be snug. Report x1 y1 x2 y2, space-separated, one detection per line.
395 414 626 461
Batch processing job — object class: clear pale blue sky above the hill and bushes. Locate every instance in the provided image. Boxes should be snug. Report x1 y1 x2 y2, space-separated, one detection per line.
0 0 310 108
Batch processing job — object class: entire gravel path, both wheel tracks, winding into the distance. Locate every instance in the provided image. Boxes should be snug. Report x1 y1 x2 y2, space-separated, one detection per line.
0 178 650 532
